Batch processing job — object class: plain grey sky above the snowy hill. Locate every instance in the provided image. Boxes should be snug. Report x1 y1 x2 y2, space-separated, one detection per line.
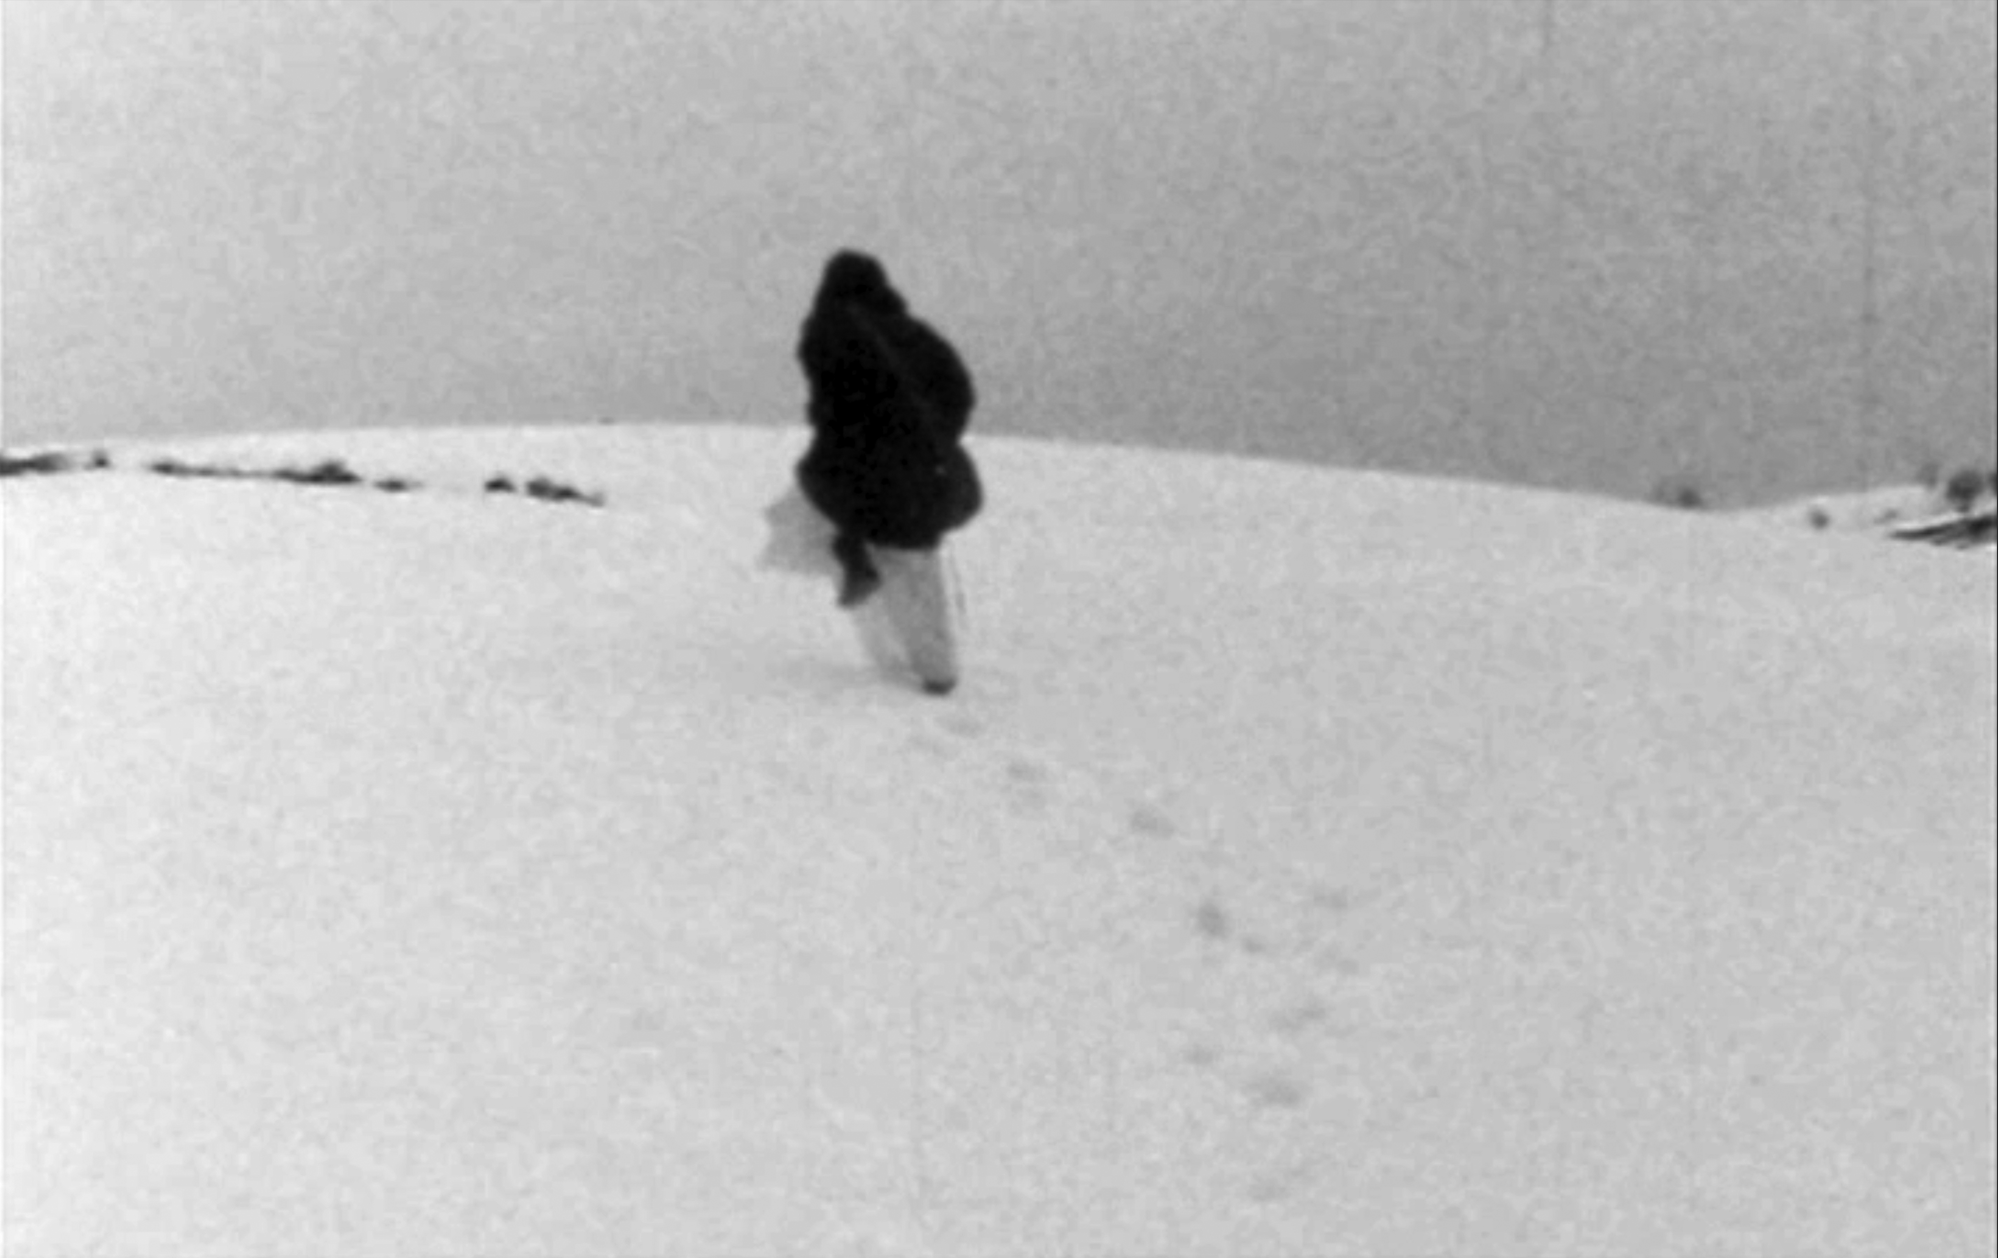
0 0 1998 501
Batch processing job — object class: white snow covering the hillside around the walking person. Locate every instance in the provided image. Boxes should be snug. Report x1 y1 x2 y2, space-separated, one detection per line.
4 427 1998 1258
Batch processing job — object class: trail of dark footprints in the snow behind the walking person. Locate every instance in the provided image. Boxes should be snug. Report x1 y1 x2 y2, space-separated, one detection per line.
915 713 1371 1202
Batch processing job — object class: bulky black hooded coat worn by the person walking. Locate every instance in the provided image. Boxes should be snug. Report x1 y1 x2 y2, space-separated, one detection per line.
797 252 985 549
